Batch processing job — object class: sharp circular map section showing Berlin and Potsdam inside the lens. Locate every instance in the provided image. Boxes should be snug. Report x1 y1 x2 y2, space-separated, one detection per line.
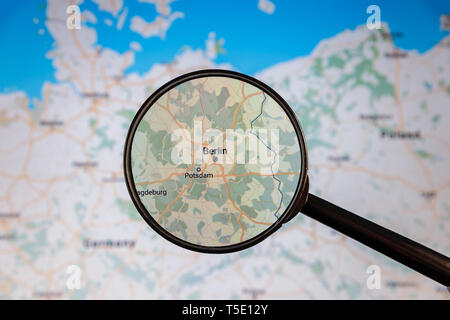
131 76 302 246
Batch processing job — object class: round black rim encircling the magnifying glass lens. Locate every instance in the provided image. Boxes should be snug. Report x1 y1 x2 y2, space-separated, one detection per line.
124 69 308 253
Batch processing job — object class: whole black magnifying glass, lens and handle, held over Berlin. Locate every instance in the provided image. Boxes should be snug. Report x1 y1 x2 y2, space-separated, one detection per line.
124 70 450 287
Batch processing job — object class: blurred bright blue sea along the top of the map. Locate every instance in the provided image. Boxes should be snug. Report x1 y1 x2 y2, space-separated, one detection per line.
0 0 450 107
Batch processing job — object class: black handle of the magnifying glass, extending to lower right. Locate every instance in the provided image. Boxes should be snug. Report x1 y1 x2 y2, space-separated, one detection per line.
301 194 450 287
